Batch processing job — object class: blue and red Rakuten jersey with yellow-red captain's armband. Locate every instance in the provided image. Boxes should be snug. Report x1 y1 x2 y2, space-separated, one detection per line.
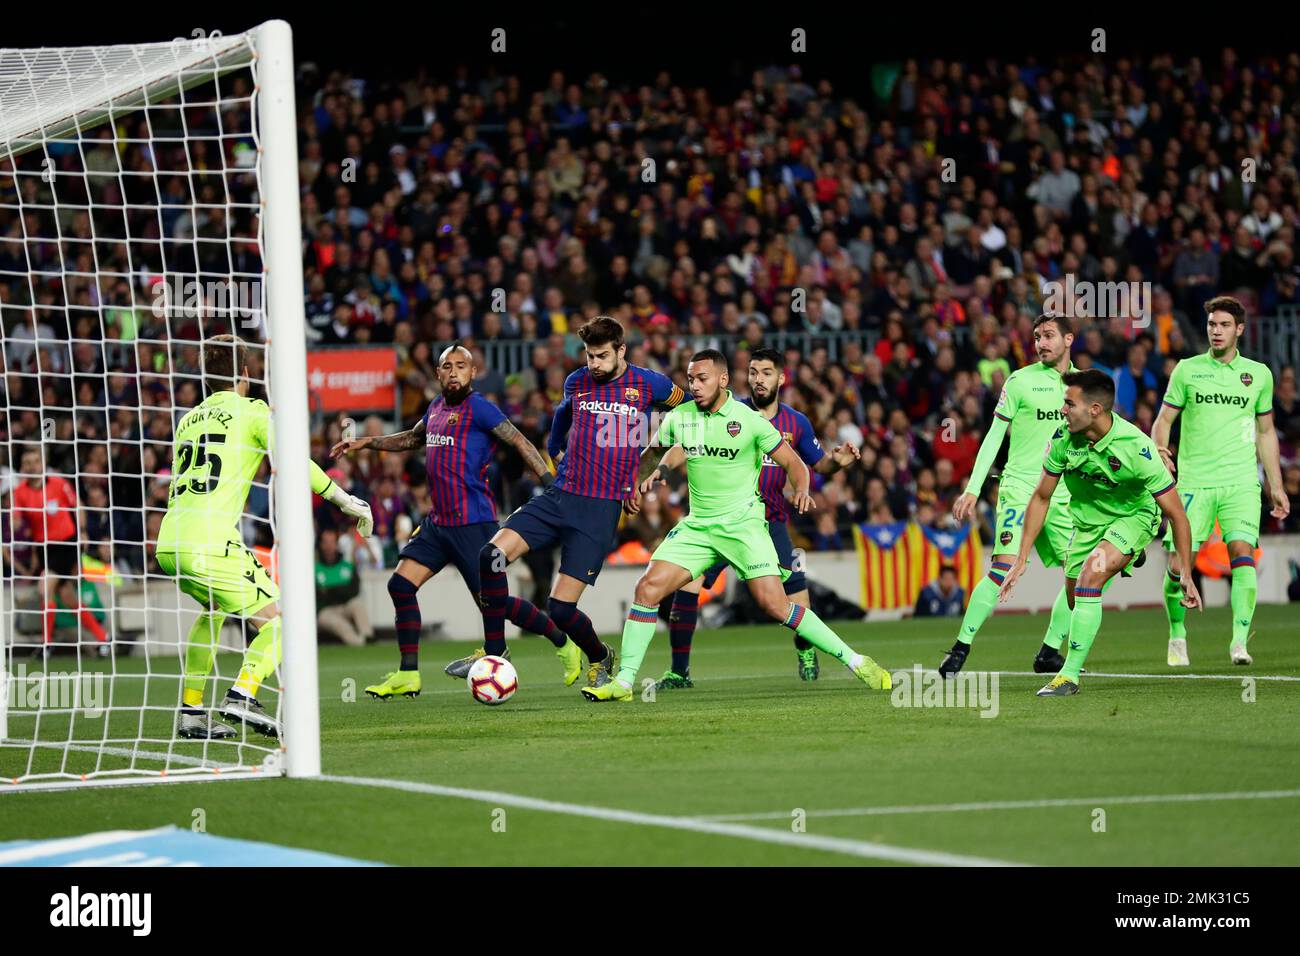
547 365 686 499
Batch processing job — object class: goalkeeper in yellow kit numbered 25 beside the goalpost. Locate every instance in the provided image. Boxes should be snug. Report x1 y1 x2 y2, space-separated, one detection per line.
157 336 373 740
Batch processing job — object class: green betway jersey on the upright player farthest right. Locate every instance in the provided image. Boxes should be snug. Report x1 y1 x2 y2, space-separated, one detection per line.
1165 352 1273 488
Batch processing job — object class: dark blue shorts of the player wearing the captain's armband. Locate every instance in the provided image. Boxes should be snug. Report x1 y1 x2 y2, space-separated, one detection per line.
506 485 623 584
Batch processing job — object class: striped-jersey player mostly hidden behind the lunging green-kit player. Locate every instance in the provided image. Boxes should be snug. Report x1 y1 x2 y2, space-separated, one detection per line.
631 349 862 689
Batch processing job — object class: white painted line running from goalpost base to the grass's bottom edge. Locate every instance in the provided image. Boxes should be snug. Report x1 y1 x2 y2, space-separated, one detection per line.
317 774 1023 866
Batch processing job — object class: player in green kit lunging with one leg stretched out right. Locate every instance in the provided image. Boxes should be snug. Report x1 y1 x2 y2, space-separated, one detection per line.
582 349 892 701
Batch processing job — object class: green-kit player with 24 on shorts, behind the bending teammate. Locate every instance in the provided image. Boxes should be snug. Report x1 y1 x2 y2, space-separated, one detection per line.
939 315 1074 679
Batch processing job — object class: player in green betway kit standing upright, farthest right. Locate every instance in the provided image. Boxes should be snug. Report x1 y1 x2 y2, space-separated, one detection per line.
1151 295 1291 667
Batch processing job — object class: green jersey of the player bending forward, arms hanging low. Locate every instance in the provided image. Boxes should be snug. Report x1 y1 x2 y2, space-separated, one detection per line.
1043 415 1174 528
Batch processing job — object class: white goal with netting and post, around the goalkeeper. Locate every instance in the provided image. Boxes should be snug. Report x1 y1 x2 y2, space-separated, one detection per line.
0 21 320 792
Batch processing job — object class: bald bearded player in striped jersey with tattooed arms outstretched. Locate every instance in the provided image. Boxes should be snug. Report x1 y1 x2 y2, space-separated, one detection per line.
330 345 582 700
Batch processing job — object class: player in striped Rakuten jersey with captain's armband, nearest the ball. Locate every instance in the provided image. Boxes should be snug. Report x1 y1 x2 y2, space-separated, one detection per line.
446 316 685 687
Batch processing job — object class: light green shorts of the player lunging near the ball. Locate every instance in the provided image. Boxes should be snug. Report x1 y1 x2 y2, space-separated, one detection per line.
650 497 790 583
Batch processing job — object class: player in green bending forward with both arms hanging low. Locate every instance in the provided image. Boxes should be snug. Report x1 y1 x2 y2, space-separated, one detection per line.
998 368 1201 697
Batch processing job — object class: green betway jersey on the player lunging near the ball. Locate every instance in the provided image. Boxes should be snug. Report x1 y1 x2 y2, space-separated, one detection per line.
655 389 783 518
